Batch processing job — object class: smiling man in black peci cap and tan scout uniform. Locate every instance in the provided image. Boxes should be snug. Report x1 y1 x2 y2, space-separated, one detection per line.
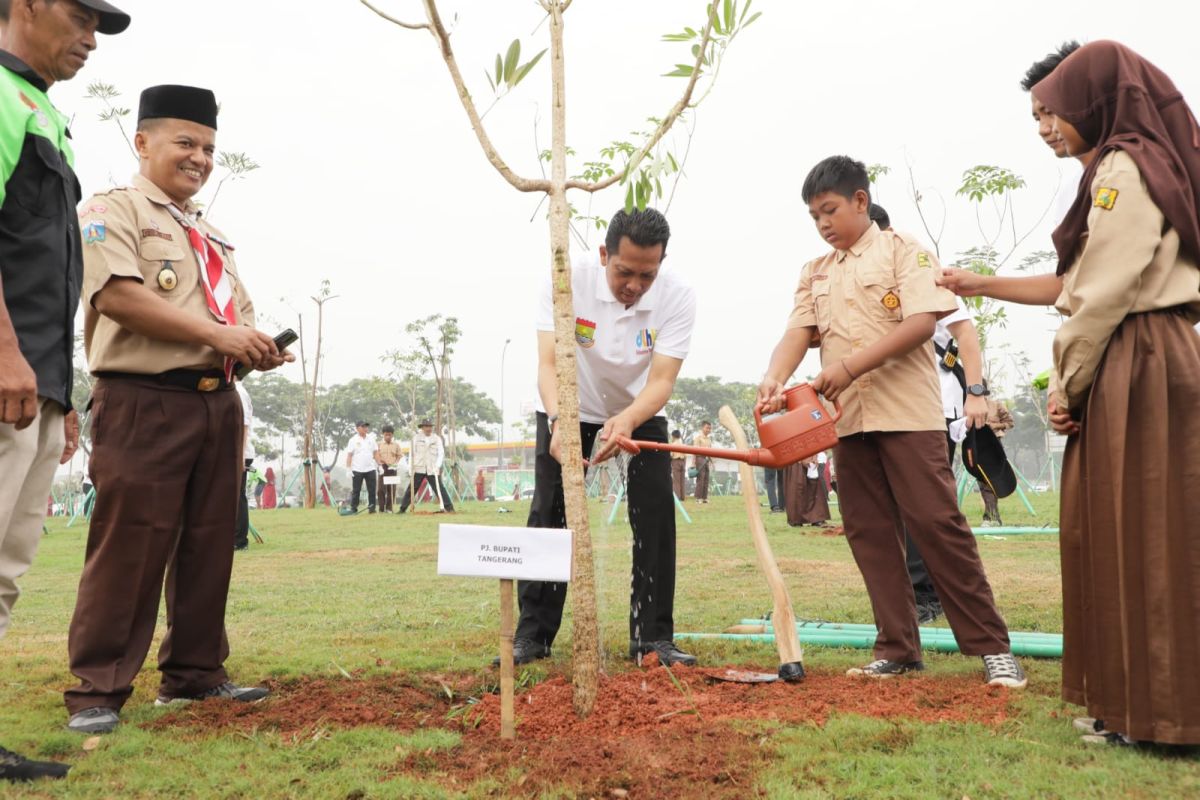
65 86 293 733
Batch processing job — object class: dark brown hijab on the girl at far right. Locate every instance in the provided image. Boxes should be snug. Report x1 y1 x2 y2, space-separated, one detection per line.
1033 41 1200 275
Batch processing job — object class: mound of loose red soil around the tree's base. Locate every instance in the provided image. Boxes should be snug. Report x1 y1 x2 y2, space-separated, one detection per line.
149 658 1009 798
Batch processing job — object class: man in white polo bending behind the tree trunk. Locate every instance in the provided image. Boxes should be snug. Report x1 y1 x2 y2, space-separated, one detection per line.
501 209 696 664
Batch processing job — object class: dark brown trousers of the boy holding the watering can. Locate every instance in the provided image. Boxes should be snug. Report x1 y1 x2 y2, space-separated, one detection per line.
835 431 1009 662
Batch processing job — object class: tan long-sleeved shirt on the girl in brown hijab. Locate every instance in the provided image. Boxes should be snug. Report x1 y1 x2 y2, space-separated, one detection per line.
1051 150 1200 413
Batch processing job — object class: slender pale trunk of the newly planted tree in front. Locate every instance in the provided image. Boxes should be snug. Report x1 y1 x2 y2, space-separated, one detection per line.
550 4 600 718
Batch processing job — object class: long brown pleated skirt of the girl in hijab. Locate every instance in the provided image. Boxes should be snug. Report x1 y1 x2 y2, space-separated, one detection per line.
1061 311 1200 745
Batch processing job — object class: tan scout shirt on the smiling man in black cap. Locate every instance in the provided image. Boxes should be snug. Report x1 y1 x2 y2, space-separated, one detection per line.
80 175 254 374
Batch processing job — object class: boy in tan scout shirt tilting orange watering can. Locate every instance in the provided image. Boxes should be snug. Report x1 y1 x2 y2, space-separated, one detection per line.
758 156 1026 688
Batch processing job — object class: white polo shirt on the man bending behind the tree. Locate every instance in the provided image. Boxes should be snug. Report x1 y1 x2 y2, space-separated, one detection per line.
536 252 696 425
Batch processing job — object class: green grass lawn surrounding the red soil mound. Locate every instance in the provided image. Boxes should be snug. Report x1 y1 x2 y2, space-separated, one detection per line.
0 494 1200 800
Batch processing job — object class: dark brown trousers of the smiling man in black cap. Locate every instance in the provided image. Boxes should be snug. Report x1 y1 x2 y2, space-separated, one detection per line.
65 378 242 714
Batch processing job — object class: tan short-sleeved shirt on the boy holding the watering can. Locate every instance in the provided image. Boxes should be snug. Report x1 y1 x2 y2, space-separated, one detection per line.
787 223 958 437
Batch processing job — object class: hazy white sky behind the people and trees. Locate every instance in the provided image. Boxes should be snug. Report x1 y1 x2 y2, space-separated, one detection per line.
52 0 1200 438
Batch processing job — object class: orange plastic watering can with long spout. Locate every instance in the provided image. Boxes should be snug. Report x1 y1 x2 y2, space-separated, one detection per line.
617 384 841 469
